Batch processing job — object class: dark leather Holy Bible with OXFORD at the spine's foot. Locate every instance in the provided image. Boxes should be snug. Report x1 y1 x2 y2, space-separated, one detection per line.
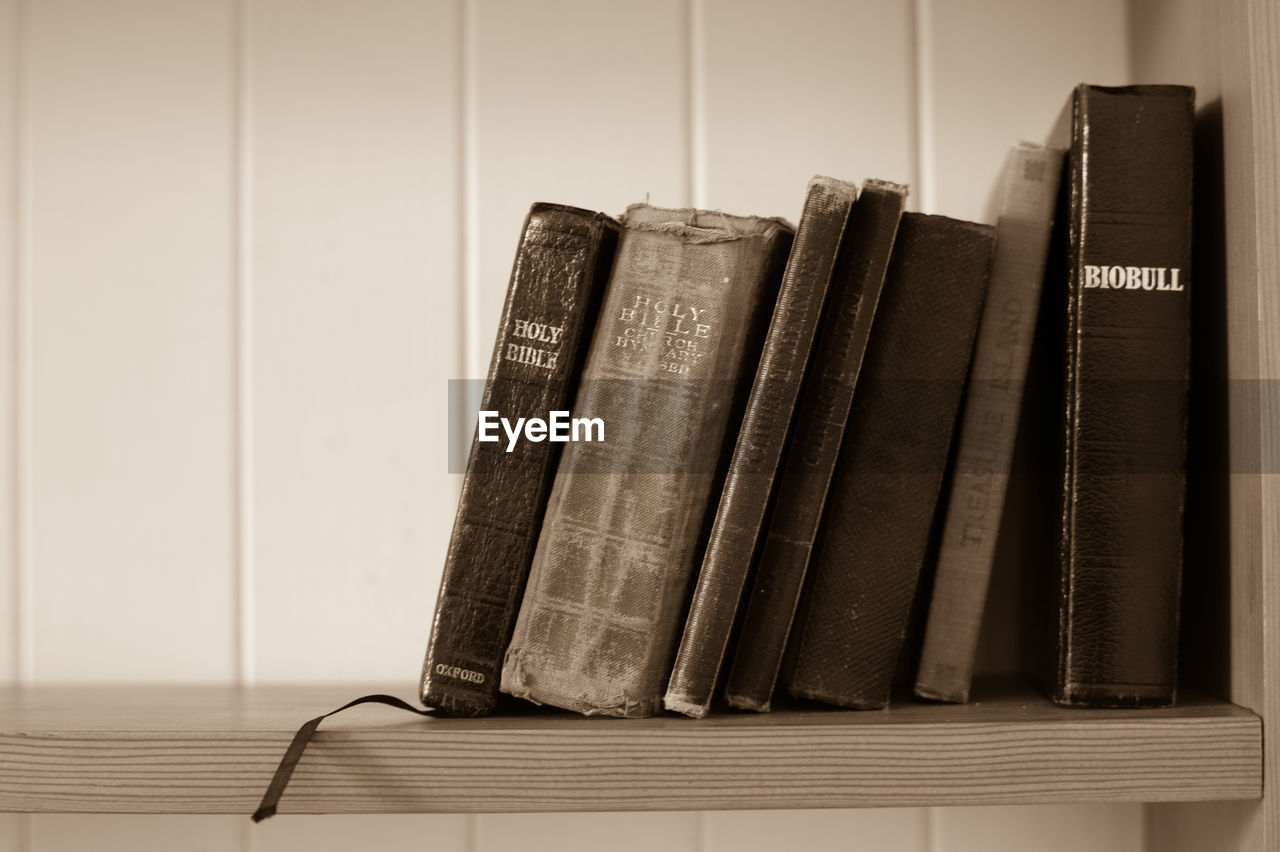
420 203 621 716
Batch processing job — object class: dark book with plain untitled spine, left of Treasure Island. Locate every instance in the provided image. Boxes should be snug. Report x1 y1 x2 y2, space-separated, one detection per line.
788 214 995 709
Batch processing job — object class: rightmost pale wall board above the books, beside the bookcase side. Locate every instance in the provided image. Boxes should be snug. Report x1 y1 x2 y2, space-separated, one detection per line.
924 0 1129 221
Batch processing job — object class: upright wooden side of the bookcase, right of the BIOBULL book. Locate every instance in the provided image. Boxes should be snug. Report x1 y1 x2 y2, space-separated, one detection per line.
1132 0 1280 852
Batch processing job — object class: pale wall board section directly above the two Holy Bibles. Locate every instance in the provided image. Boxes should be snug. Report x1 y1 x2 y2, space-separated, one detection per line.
468 0 689 379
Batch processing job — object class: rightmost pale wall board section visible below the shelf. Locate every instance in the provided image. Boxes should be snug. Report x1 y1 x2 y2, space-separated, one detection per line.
931 803 1144 852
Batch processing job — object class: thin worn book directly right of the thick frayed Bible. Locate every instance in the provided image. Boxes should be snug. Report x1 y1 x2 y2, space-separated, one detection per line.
663 177 858 719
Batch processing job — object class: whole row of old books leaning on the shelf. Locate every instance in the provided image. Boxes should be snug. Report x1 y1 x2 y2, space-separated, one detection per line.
421 86 1194 716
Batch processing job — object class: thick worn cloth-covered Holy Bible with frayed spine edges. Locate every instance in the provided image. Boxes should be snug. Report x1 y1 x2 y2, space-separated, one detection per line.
502 205 792 716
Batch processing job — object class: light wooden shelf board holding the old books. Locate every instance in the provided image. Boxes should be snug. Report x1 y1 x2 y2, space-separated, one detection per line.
0 683 1262 815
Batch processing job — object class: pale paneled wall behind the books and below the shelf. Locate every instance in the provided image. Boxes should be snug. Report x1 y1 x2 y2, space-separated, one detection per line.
0 0 1143 852
